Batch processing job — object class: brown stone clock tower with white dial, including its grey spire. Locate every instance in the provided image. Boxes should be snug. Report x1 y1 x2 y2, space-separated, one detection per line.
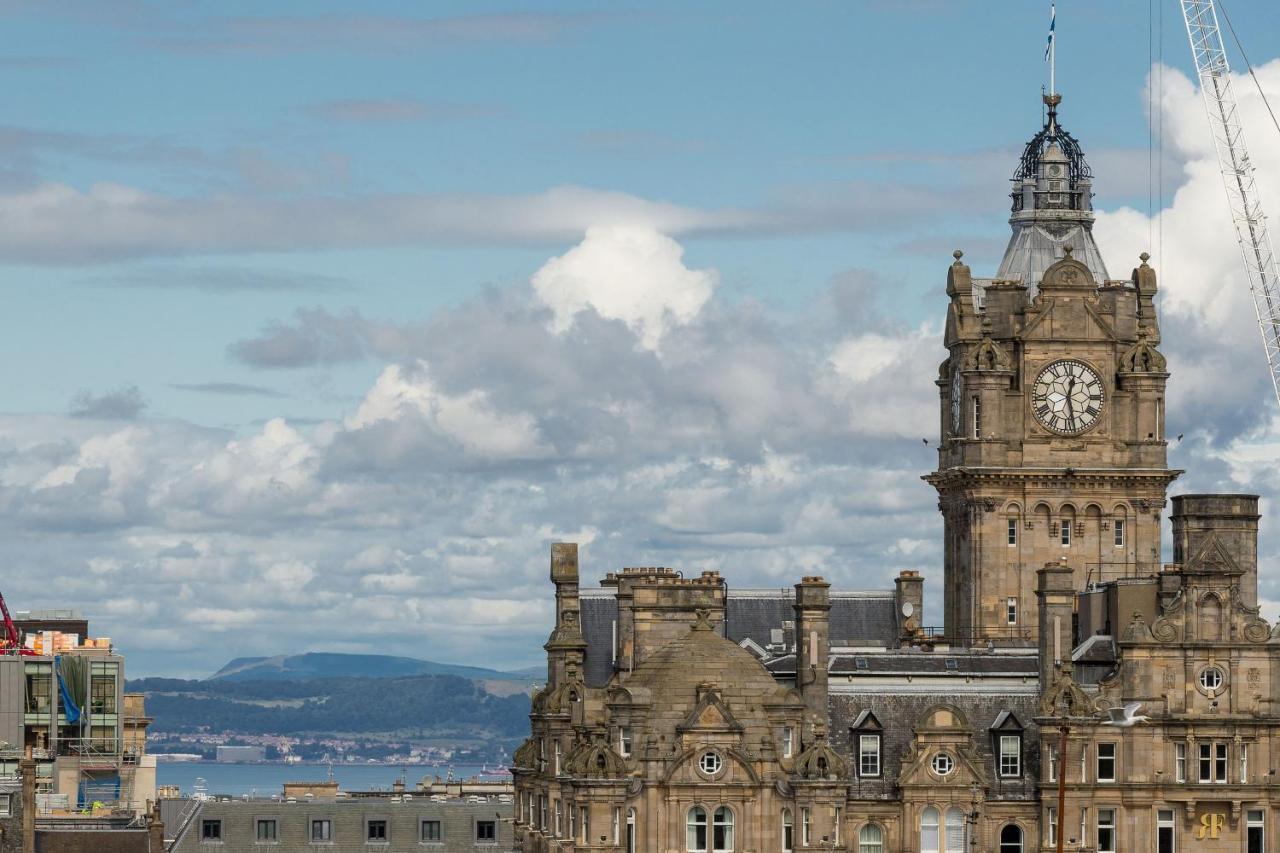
924 95 1180 643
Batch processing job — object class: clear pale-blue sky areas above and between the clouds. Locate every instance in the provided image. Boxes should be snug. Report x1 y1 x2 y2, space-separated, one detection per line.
4 1 1223 425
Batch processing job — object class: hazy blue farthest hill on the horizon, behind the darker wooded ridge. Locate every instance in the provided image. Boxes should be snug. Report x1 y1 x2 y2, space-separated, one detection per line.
206 652 535 683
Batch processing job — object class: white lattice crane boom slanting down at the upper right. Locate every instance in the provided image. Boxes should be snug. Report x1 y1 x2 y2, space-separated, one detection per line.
1180 0 1280 400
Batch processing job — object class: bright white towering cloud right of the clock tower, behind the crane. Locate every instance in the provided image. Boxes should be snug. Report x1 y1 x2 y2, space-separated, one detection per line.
1094 60 1280 447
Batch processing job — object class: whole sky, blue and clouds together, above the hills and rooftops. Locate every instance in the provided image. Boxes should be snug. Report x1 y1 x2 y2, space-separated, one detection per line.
0 0 1280 676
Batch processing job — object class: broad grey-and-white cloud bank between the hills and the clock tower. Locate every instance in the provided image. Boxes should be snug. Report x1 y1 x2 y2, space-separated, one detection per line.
0 231 941 672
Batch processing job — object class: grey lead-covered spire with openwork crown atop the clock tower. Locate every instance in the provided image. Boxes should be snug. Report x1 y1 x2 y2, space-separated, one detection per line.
996 95 1107 286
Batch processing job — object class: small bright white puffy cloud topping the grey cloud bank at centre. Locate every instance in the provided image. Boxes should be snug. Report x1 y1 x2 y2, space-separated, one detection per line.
532 225 718 351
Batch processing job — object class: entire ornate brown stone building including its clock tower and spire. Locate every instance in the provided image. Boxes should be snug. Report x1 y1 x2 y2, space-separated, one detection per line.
513 96 1280 853
